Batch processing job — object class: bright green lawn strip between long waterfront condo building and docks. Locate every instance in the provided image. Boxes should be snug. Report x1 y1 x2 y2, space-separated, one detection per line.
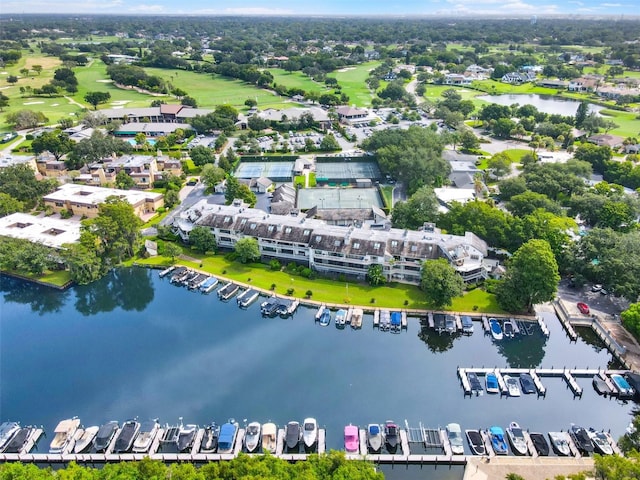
128 249 502 313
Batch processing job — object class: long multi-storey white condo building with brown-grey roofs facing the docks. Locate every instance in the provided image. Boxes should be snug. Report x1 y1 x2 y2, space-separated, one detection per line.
173 200 487 285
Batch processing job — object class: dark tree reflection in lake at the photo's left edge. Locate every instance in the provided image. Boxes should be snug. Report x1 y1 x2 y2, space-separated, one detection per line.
0 275 69 315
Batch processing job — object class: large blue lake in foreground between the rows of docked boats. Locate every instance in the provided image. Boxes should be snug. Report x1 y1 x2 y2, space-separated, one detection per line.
0 269 632 460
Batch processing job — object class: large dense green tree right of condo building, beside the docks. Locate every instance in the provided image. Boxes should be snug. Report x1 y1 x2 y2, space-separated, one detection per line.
496 239 560 312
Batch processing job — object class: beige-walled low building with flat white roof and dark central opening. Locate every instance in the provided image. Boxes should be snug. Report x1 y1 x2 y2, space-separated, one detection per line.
42 183 164 218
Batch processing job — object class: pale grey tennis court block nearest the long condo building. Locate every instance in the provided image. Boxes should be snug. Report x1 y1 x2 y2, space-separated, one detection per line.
298 188 383 210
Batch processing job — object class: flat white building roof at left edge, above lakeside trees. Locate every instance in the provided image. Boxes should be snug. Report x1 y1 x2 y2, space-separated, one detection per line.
0 213 80 248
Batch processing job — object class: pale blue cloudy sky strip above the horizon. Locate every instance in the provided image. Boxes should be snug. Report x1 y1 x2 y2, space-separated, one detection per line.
0 0 640 17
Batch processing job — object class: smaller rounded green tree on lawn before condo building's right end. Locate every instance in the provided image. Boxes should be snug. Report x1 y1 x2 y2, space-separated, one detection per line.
420 258 464 309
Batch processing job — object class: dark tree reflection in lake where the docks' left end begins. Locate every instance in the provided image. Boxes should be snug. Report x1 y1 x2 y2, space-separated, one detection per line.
75 268 154 316
